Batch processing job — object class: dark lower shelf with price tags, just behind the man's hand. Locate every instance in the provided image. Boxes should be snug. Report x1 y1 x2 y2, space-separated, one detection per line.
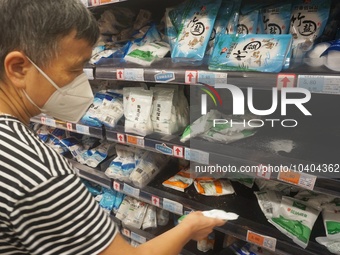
73 158 331 255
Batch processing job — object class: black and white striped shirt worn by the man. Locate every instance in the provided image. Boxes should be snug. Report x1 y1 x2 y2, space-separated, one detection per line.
0 115 118 255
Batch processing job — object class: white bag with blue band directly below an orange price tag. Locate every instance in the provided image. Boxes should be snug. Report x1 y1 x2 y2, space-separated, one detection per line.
105 144 144 182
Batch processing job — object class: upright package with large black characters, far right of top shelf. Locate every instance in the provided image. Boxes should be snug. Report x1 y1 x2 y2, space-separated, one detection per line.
290 0 331 63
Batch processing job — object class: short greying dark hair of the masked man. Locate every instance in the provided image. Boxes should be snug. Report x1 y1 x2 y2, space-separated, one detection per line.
0 0 99 78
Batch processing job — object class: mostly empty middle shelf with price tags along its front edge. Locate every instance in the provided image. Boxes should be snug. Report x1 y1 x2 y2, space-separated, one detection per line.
32 116 340 196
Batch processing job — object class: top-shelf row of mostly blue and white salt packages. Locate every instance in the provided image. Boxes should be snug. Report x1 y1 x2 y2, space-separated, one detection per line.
90 0 340 72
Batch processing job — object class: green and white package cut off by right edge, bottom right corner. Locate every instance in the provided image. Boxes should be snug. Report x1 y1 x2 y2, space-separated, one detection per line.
322 202 340 243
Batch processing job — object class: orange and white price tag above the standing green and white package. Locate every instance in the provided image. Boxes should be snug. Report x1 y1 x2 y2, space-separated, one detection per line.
277 171 316 190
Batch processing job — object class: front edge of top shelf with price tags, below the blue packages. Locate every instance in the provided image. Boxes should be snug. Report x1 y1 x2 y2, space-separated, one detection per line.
95 58 340 95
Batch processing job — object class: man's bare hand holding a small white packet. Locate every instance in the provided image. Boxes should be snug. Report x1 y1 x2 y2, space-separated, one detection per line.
180 211 226 241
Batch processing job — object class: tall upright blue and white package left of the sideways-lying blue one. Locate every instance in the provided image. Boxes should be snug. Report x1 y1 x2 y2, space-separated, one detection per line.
171 0 221 63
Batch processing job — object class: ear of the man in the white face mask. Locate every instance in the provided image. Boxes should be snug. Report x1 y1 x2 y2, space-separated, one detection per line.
4 51 32 89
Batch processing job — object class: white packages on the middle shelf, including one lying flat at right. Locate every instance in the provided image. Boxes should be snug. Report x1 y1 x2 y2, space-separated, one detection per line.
75 84 264 144
